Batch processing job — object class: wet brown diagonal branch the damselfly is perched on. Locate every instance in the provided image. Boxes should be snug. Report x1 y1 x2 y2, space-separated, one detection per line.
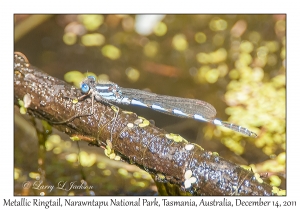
14 53 276 195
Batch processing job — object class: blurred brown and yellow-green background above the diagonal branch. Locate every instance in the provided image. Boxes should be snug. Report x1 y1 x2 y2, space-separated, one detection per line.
15 14 286 195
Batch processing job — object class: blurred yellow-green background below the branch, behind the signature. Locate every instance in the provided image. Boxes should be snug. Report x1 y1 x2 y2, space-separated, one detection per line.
14 115 156 195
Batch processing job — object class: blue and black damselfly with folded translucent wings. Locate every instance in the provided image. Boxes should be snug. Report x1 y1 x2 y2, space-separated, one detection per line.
81 76 257 137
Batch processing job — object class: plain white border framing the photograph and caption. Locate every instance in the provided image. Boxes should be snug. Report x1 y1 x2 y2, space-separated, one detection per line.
0 0 300 209
